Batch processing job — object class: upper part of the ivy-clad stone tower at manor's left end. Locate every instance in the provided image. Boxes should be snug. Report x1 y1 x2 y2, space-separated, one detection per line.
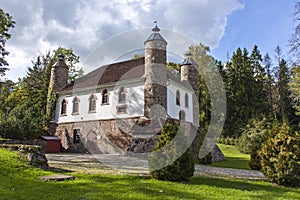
49 55 69 92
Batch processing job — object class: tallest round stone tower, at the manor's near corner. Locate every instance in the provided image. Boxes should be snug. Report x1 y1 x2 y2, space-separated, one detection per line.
144 25 167 118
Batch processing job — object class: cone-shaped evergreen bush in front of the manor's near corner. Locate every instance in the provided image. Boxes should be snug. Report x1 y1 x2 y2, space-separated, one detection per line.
149 123 195 181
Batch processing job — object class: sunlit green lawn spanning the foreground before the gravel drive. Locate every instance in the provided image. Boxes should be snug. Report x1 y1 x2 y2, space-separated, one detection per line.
0 149 300 200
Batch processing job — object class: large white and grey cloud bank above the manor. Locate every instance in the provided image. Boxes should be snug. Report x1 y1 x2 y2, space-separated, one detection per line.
0 0 243 80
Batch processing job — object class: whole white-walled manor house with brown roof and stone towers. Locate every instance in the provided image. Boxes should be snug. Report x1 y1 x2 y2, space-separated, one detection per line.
49 26 199 153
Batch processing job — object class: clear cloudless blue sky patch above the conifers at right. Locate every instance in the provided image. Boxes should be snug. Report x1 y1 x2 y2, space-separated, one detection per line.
212 0 296 61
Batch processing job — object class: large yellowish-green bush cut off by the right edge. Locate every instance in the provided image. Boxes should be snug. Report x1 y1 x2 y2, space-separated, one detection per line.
259 123 300 187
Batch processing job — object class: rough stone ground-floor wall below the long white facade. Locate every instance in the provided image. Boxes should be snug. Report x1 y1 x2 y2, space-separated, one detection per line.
53 118 138 154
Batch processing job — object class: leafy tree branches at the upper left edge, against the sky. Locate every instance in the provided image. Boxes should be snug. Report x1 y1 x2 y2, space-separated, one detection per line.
0 8 15 76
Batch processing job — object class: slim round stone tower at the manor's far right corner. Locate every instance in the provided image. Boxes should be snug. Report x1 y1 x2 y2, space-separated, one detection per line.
181 53 199 126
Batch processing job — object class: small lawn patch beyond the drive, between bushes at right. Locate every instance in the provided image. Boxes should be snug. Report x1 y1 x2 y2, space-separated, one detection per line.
211 144 250 169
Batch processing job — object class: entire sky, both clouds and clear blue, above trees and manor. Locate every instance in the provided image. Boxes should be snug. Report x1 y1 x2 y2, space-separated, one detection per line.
0 0 297 81
